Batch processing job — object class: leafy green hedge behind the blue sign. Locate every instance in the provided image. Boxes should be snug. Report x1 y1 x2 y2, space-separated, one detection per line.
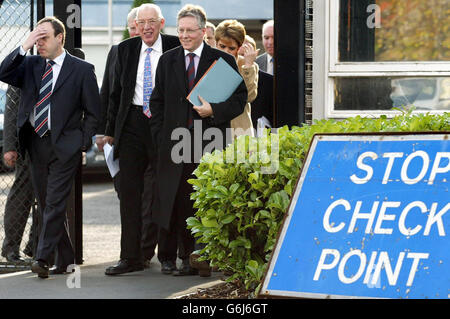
187 113 450 290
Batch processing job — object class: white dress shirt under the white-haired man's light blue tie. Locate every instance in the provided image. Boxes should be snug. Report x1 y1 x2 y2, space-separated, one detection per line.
132 34 163 105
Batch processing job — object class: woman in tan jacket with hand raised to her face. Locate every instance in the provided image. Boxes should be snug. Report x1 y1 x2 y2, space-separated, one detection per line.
214 20 259 138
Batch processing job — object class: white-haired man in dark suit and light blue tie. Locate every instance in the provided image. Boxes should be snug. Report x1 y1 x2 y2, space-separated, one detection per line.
105 3 179 275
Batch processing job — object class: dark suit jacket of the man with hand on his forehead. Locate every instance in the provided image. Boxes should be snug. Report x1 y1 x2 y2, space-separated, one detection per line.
0 48 100 162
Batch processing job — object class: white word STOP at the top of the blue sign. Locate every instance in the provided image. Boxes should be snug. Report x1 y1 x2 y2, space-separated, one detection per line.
350 151 450 185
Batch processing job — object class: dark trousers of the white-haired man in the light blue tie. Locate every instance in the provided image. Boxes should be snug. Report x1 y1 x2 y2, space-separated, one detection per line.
119 106 156 260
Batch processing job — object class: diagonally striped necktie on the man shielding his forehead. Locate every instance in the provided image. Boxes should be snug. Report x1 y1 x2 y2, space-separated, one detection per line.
34 60 55 137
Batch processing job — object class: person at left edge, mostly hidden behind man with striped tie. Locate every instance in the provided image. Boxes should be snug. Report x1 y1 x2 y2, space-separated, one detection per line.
2 85 38 263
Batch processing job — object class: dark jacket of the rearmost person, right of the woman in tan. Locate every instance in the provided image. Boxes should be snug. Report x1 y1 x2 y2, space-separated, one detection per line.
252 70 273 128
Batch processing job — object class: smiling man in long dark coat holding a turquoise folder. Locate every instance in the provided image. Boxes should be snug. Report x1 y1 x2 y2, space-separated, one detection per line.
150 5 247 275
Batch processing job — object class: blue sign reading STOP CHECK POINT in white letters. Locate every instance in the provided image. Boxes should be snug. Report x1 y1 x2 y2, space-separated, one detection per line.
261 134 450 299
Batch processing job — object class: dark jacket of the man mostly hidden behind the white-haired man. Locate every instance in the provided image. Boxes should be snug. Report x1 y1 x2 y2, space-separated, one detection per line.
97 45 119 134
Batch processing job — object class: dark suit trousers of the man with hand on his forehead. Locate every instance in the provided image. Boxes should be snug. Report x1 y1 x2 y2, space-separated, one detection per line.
30 132 81 268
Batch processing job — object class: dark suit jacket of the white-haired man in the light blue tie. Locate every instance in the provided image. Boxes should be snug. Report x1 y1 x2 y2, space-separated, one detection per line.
105 34 180 158
